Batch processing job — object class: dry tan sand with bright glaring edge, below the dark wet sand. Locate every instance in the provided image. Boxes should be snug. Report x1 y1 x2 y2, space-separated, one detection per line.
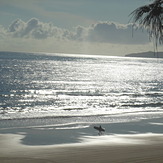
0 134 163 163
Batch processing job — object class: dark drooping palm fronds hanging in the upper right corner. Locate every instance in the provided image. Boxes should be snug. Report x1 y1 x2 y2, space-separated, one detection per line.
130 0 163 48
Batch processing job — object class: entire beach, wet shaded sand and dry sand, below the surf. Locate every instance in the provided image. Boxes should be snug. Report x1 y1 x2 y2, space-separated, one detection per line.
0 119 163 163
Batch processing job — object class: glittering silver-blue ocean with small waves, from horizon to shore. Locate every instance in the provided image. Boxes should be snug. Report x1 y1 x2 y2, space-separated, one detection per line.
0 52 163 128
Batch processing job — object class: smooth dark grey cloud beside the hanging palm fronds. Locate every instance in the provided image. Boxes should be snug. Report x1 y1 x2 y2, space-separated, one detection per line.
87 22 148 44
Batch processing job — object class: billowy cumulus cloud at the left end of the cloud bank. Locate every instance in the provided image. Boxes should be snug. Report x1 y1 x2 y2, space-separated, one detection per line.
8 18 66 39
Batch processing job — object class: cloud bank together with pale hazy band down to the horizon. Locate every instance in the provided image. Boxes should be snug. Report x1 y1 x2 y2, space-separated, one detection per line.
0 18 161 55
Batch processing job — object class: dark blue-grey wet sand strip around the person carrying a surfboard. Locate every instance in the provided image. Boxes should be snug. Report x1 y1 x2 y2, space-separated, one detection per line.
0 118 163 146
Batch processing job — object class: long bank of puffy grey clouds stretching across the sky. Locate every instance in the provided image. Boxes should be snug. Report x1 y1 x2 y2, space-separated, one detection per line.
3 18 148 44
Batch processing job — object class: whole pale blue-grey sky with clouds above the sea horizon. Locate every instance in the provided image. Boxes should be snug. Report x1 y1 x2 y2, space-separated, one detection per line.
0 0 162 56
